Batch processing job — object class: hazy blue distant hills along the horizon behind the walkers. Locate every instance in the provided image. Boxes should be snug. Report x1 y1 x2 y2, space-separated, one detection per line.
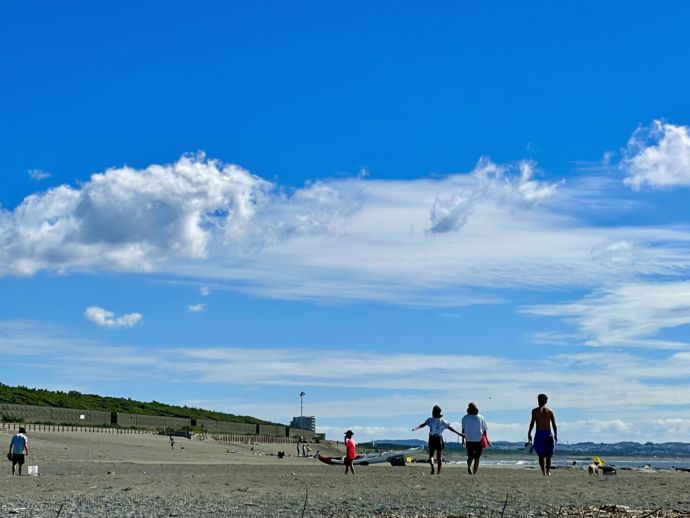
358 439 690 457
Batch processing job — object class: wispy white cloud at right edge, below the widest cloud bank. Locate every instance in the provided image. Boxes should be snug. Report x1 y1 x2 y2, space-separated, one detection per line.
523 282 690 349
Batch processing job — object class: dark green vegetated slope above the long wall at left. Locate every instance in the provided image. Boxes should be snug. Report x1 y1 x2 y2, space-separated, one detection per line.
0 383 276 424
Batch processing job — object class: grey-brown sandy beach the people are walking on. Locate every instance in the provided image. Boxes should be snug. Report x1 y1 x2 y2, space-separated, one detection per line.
0 432 690 518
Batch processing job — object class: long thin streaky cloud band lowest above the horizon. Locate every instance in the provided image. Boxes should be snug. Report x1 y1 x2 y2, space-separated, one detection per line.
6 323 690 406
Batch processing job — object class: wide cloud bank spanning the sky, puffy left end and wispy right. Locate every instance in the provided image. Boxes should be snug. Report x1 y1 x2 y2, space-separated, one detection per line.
0 150 690 306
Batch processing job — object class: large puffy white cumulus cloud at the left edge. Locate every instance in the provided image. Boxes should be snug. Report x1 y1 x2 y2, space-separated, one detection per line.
0 152 270 275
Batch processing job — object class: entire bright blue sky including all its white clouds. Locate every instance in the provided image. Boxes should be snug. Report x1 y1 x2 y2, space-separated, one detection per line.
0 2 690 441
